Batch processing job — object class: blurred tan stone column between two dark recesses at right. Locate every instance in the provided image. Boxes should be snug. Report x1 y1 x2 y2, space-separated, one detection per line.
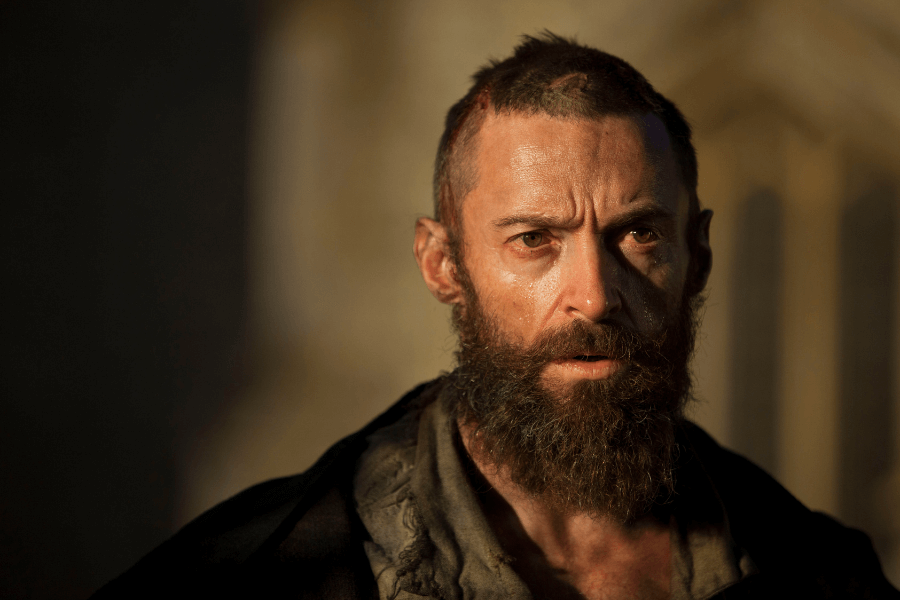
778 128 844 514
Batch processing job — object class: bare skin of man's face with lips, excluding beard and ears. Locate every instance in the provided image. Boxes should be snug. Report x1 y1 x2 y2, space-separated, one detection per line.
462 114 690 393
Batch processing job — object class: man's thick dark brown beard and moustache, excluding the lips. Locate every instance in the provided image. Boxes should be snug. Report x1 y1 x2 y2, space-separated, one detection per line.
450 275 702 524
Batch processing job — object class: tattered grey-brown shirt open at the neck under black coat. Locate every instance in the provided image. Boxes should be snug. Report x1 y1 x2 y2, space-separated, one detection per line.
353 388 756 600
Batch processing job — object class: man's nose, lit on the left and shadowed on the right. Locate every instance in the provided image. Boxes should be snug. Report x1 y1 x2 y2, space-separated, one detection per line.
562 235 622 323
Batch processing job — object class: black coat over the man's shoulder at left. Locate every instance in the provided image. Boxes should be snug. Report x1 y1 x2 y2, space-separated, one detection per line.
94 379 440 599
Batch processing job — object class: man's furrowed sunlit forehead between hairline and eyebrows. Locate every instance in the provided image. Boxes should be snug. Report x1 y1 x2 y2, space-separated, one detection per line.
463 113 687 225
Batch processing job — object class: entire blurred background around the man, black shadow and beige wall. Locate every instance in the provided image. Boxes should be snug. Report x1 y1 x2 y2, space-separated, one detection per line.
0 0 900 598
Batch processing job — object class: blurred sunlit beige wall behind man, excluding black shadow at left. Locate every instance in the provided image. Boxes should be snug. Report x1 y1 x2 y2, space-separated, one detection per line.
181 0 900 582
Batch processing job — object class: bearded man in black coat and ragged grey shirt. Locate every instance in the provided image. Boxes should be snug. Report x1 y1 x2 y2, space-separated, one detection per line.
97 34 897 598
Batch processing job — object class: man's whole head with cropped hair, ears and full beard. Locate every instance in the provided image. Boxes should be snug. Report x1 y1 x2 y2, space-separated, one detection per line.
415 35 711 520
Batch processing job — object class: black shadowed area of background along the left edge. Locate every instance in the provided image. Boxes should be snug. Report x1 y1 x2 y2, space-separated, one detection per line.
0 0 255 598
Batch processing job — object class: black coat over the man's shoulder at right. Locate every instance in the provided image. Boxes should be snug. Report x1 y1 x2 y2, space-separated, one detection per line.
683 423 900 598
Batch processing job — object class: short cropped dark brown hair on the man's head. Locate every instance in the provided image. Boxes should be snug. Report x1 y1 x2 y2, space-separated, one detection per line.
434 31 699 260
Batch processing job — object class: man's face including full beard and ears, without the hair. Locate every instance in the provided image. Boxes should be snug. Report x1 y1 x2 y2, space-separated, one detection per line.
428 111 708 522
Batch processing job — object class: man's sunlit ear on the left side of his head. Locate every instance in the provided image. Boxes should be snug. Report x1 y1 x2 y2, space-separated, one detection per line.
413 217 463 304
